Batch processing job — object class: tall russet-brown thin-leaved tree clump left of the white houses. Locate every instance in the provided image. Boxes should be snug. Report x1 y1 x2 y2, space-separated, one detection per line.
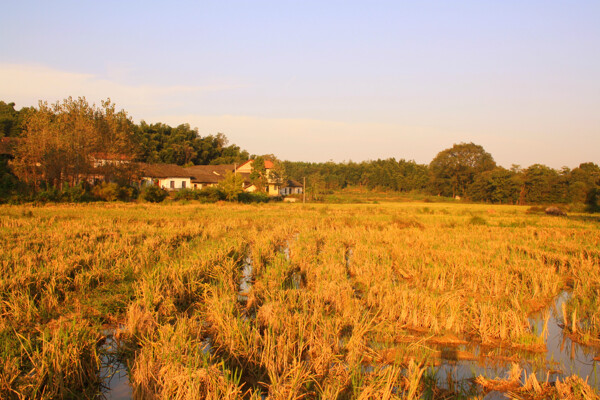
13 97 133 187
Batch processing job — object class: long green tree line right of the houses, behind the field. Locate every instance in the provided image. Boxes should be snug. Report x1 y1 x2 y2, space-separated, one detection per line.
283 143 600 209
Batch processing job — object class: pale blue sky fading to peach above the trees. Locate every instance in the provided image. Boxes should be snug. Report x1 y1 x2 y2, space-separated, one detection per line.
0 0 600 168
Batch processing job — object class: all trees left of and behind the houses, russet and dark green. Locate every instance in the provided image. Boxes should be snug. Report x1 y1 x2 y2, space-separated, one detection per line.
0 97 250 197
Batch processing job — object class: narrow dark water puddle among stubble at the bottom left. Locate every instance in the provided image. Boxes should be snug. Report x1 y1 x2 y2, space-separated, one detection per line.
100 328 133 400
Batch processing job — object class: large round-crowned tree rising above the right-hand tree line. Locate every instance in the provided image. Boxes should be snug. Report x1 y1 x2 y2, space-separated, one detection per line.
429 143 496 197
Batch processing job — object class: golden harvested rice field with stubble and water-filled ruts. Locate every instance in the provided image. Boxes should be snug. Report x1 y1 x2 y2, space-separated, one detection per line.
0 203 600 399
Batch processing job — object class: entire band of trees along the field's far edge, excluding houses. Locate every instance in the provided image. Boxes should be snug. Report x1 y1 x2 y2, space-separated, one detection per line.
0 98 600 210
